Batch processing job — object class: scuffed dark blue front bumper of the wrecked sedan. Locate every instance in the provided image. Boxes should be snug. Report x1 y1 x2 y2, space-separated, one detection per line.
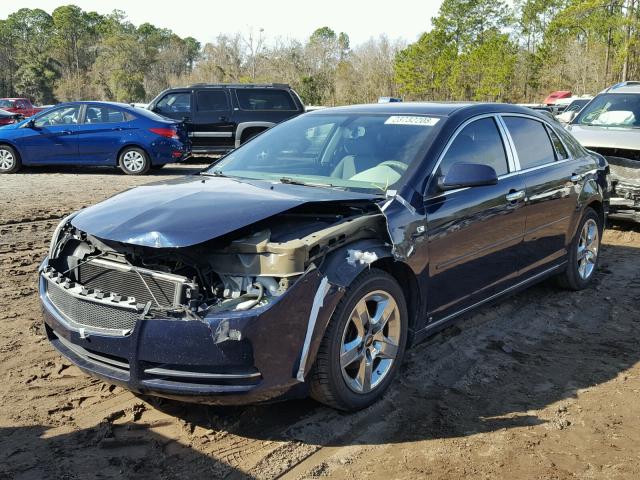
40 260 341 405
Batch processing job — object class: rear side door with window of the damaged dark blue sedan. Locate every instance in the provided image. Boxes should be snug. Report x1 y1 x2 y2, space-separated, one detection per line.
502 115 581 276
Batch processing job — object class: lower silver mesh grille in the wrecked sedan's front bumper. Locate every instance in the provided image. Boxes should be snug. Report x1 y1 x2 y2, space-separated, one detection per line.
47 281 140 331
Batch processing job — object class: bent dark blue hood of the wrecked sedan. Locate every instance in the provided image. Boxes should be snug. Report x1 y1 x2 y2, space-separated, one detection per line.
71 176 379 248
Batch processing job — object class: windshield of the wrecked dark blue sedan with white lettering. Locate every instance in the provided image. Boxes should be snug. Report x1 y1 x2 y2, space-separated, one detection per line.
204 114 440 192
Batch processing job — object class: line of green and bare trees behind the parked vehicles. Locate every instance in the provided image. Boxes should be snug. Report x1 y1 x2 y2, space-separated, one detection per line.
0 0 640 105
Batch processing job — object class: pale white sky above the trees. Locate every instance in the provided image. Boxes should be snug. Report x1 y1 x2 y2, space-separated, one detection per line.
0 0 441 46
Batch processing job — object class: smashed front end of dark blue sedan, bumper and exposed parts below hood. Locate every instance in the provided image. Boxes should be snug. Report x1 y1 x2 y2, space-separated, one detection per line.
40 201 387 403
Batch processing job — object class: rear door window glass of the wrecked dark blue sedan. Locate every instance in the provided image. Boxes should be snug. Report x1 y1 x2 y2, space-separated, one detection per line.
503 116 556 170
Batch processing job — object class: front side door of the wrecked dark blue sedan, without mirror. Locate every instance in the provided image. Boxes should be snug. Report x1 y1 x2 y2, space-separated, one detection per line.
425 117 525 323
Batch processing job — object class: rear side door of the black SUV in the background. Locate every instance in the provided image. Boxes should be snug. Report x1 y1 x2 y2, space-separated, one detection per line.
190 88 236 151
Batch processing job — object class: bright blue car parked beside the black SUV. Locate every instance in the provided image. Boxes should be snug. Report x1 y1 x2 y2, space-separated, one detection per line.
0 102 191 175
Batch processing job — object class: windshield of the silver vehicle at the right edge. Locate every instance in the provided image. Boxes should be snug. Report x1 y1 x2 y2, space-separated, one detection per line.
573 93 640 128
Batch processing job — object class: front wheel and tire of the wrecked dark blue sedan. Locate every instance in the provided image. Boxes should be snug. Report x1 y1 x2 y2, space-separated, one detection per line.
311 268 408 411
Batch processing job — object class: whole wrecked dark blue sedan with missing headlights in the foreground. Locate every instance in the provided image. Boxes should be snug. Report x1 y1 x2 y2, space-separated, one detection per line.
40 103 610 410
